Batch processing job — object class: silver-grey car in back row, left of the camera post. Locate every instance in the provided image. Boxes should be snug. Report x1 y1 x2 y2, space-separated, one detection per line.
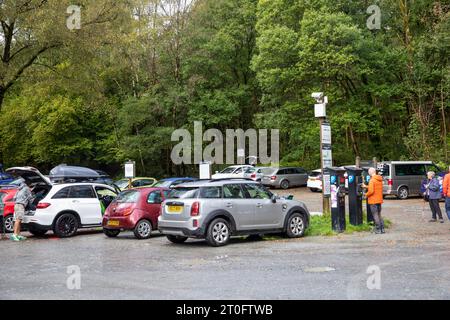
261 167 308 189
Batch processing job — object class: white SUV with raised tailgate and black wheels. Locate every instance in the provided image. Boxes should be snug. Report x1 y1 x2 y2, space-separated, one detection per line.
6 167 117 238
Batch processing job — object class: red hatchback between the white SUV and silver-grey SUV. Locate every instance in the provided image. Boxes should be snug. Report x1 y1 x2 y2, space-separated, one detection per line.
103 188 170 239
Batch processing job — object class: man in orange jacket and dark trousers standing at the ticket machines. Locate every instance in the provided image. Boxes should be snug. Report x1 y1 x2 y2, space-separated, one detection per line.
363 168 384 234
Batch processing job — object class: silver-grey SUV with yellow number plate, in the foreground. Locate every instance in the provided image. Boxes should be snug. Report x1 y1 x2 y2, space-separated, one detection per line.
158 179 309 246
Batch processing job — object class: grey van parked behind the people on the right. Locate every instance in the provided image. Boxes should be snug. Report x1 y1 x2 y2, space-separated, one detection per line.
378 161 445 199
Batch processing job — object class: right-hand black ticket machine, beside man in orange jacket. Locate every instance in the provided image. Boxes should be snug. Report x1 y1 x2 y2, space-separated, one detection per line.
345 166 363 226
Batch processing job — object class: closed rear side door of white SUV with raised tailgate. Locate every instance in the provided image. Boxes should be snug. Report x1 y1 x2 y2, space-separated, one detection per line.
67 185 102 225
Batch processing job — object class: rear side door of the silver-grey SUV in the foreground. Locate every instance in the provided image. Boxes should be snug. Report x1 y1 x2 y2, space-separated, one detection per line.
223 184 255 230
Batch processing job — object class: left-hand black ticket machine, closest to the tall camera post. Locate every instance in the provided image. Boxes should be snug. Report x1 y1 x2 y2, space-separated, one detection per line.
328 167 345 232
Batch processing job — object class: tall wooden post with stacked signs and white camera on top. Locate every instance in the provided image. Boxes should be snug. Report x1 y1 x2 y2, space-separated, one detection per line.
311 92 333 215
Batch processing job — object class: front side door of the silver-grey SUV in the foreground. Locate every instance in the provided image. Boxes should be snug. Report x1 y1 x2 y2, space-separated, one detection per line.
244 183 282 230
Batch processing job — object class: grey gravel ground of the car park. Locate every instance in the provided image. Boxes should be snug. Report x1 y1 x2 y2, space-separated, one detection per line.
0 188 450 299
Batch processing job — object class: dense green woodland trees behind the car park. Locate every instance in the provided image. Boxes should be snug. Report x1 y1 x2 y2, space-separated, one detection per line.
0 0 450 176
